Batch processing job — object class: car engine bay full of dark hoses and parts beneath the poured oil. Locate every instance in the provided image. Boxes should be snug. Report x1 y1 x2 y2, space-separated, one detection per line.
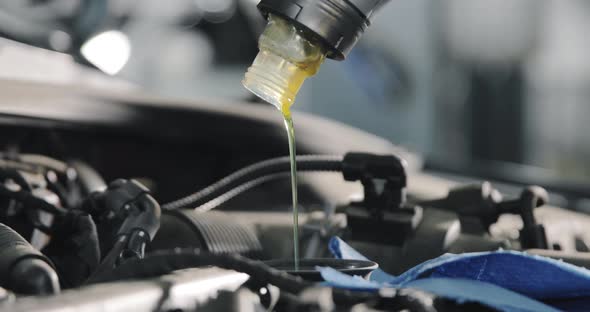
0 83 590 311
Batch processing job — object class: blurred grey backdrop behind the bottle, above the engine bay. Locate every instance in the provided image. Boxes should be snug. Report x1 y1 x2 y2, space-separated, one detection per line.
0 0 590 208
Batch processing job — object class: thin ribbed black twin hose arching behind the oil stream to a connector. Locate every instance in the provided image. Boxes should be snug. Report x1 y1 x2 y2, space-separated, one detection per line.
162 155 342 210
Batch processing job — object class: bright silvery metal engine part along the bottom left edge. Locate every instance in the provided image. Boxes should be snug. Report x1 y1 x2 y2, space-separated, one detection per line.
0 268 256 312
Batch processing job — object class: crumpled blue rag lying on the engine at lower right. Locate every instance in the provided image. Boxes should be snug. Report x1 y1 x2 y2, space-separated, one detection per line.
319 237 590 312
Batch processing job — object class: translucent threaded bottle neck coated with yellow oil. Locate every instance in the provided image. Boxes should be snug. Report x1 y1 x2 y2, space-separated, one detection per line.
242 15 326 114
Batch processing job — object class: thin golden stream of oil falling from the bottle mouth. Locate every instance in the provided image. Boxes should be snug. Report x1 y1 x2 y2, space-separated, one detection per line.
282 105 299 270
